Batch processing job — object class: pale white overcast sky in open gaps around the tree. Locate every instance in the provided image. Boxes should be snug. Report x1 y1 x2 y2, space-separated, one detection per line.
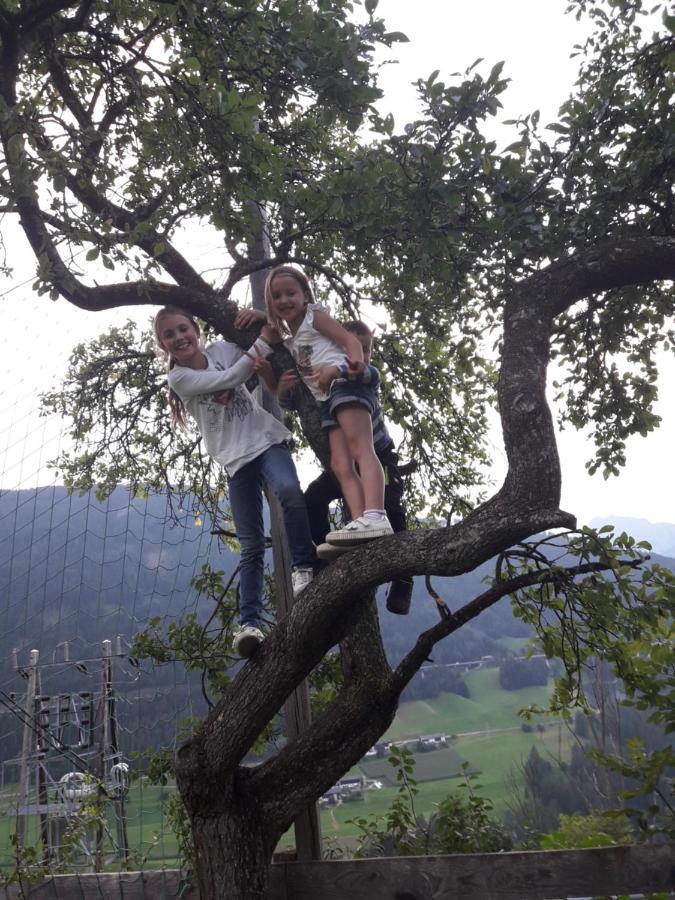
0 0 675 523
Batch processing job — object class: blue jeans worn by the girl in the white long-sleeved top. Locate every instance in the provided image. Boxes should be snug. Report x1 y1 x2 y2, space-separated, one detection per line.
228 444 315 625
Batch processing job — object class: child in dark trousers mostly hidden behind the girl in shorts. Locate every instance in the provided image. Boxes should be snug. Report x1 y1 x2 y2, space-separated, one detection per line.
305 321 413 615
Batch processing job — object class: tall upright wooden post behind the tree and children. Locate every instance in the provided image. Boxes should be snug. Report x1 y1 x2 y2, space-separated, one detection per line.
250 221 321 861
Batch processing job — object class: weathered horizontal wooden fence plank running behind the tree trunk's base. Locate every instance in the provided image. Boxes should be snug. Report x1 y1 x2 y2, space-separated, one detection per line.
0 844 675 900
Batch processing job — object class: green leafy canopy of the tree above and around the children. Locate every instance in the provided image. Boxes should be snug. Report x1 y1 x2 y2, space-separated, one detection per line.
0 0 675 512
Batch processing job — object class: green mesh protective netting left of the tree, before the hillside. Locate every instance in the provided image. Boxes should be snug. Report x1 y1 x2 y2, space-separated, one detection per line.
0 279 227 872
